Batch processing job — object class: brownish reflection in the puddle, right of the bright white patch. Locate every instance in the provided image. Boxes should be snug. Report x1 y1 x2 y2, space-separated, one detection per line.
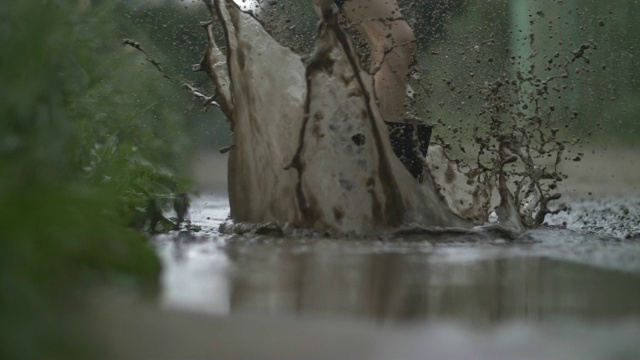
210 245 640 325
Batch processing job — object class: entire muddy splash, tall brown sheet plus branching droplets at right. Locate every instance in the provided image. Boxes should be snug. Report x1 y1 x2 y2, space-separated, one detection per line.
198 0 589 233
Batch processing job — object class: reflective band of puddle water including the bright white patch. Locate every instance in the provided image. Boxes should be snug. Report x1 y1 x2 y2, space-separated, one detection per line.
157 198 640 325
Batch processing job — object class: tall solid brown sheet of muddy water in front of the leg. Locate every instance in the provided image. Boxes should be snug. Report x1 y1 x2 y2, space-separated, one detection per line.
198 0 536 233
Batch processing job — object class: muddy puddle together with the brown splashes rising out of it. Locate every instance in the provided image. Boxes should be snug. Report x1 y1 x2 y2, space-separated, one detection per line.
113 1 640 359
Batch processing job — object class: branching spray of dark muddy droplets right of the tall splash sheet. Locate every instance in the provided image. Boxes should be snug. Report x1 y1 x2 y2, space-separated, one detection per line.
429 39 597 228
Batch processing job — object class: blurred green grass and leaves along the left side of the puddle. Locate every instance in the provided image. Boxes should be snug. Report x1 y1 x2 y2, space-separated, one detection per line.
0 0 191 359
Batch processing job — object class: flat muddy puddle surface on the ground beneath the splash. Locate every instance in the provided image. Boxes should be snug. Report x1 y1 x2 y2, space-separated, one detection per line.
140 196 640 359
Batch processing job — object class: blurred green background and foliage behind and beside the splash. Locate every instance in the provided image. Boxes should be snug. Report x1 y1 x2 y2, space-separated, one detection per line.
0 0 640 358
